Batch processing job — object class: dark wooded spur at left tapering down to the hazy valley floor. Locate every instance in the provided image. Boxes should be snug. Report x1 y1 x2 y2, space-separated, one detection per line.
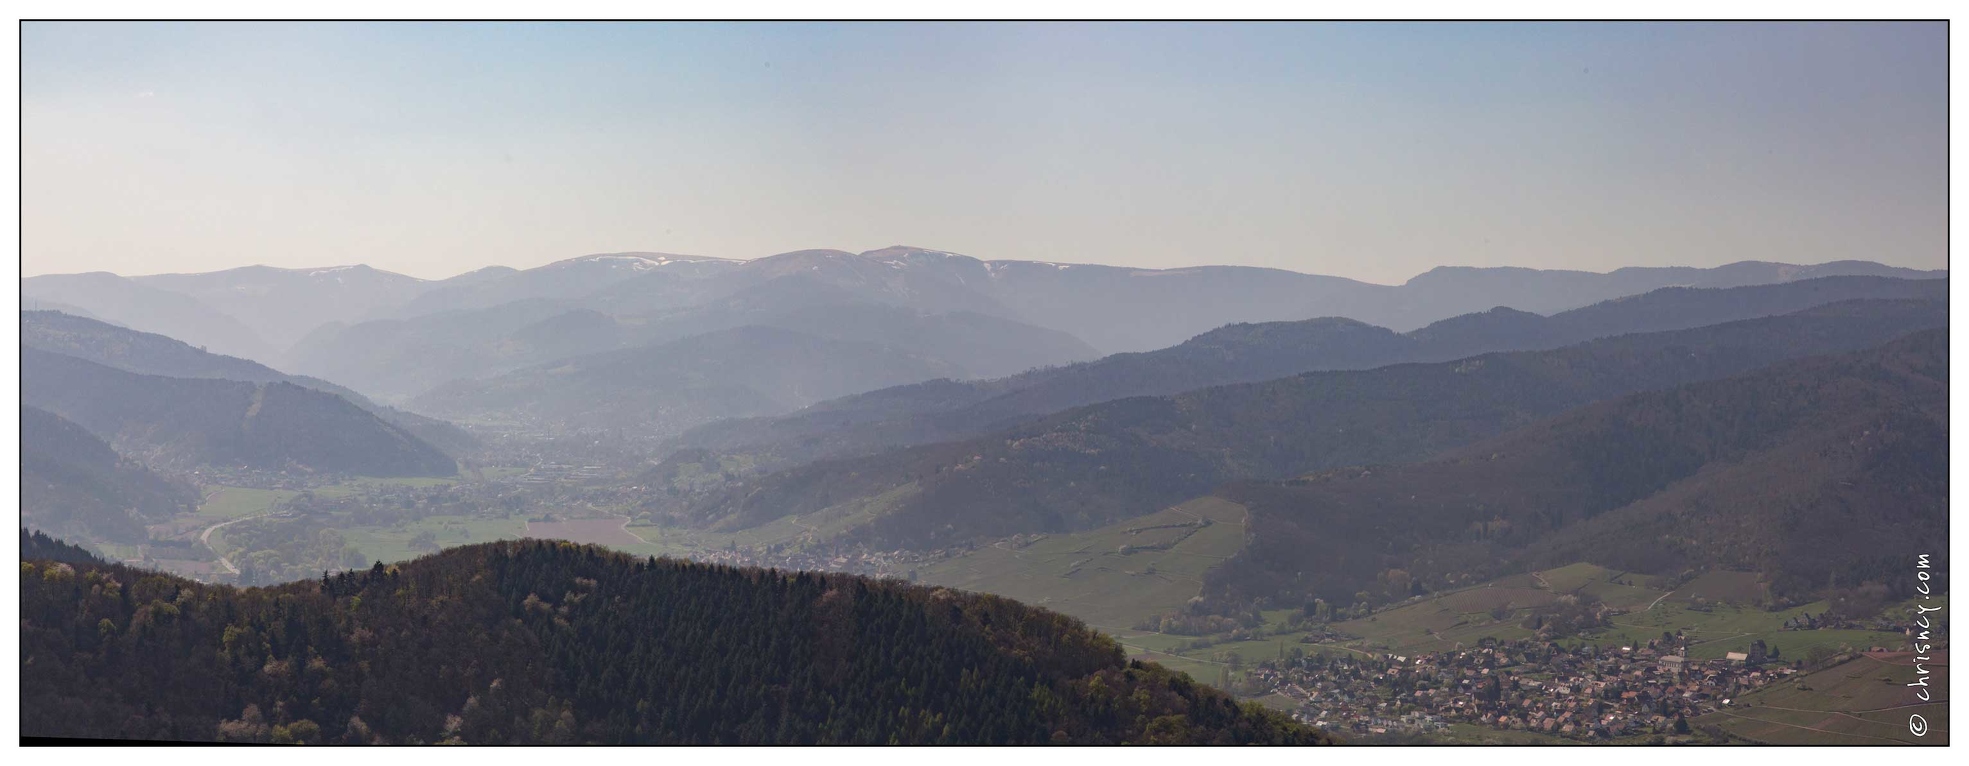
20 349 457 477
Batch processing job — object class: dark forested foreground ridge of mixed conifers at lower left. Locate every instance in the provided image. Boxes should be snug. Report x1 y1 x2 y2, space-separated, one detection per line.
20 534 1327 744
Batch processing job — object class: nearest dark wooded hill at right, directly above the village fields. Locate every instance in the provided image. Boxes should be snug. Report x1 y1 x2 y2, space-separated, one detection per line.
1207 329 1949 605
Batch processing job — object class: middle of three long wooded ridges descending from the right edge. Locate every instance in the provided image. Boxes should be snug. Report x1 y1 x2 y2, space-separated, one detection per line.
654 301 1947 547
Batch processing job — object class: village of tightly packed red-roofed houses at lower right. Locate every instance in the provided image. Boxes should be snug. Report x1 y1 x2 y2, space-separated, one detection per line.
1252 640 1796 738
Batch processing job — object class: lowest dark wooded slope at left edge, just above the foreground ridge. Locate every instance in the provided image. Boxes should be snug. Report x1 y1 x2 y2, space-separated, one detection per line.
20 406 199 543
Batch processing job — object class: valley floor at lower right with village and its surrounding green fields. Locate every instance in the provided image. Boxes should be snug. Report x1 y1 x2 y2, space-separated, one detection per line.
1217 565 1947 744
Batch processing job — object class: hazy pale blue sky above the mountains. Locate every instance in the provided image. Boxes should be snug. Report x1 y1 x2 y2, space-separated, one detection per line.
22 24 1947 282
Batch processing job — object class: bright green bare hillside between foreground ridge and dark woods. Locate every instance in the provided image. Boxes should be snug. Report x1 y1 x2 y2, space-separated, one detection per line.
920 498 1244 634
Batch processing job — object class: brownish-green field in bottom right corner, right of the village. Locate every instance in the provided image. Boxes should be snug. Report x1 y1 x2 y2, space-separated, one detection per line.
1691 654 1949 744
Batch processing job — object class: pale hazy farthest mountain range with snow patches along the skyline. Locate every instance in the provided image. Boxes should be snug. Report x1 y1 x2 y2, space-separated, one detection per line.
22 246 1943 400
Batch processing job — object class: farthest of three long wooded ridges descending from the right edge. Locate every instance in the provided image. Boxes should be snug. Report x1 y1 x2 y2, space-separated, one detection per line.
677 278 1947 469
